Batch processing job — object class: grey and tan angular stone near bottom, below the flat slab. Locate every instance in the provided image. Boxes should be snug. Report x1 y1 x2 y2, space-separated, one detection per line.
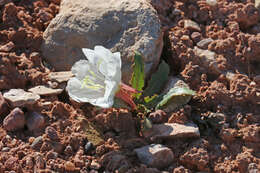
134 144 174 168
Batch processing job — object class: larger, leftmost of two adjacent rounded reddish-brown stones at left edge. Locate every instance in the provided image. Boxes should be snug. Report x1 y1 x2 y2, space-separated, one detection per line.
3 108 25 131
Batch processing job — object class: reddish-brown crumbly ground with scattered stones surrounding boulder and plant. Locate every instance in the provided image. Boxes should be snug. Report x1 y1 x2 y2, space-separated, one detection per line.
0 0 260 173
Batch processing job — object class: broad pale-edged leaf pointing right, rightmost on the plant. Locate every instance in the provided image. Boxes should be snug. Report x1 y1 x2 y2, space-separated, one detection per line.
156 87 196 112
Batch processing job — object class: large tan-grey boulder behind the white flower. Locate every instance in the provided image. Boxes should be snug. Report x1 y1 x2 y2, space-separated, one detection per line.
42 0 163 82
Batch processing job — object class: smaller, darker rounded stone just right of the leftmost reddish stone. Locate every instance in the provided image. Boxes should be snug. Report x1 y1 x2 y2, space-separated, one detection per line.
26 112 44 131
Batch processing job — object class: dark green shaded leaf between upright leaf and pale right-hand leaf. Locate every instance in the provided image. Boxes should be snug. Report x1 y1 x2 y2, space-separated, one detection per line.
143 61 170 97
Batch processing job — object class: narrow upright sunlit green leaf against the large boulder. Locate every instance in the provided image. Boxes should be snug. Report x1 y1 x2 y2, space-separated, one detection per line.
130 51 144 98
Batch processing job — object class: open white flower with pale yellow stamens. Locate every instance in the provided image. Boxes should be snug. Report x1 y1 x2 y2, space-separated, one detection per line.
66 46 121 108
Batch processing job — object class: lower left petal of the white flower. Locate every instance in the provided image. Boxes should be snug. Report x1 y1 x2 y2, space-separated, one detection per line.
66 77 105 103
